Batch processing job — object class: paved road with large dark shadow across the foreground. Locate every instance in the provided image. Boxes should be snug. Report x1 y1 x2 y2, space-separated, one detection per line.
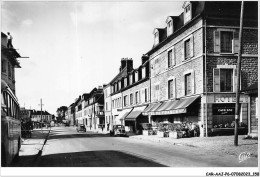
27 127 254 167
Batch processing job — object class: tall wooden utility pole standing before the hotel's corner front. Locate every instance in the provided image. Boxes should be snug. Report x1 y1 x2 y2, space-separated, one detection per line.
234 1 244 146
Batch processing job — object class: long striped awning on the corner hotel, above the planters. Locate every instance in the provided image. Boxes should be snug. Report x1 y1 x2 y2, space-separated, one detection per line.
150 96 200 115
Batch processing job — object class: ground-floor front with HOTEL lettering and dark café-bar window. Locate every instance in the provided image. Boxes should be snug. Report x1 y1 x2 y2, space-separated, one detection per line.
205 93 248 135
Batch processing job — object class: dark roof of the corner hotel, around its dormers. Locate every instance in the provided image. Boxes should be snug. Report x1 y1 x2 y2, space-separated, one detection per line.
147 1 258 55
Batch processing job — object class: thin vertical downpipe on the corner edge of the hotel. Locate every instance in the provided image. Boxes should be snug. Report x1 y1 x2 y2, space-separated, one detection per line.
204 19 208 137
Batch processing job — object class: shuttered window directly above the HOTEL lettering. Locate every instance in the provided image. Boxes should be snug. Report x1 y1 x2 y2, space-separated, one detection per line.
213 68 237 92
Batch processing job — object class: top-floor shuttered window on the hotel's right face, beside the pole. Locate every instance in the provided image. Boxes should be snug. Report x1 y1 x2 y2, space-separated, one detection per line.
214 29 239 53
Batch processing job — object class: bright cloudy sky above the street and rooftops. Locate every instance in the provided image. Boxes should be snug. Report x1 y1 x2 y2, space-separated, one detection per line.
1 1 184 115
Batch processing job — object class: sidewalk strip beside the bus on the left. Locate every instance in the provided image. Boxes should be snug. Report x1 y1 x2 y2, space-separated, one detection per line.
13 128 50 167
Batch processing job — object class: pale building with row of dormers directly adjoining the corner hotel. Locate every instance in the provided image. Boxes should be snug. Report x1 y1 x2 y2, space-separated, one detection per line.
119 56 150 133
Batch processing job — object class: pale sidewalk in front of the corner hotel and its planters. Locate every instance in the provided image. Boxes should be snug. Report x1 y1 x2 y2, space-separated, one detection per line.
129 135 258 158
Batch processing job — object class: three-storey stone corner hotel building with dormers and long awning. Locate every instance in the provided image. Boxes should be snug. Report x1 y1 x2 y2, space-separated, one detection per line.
143 1 258 136
